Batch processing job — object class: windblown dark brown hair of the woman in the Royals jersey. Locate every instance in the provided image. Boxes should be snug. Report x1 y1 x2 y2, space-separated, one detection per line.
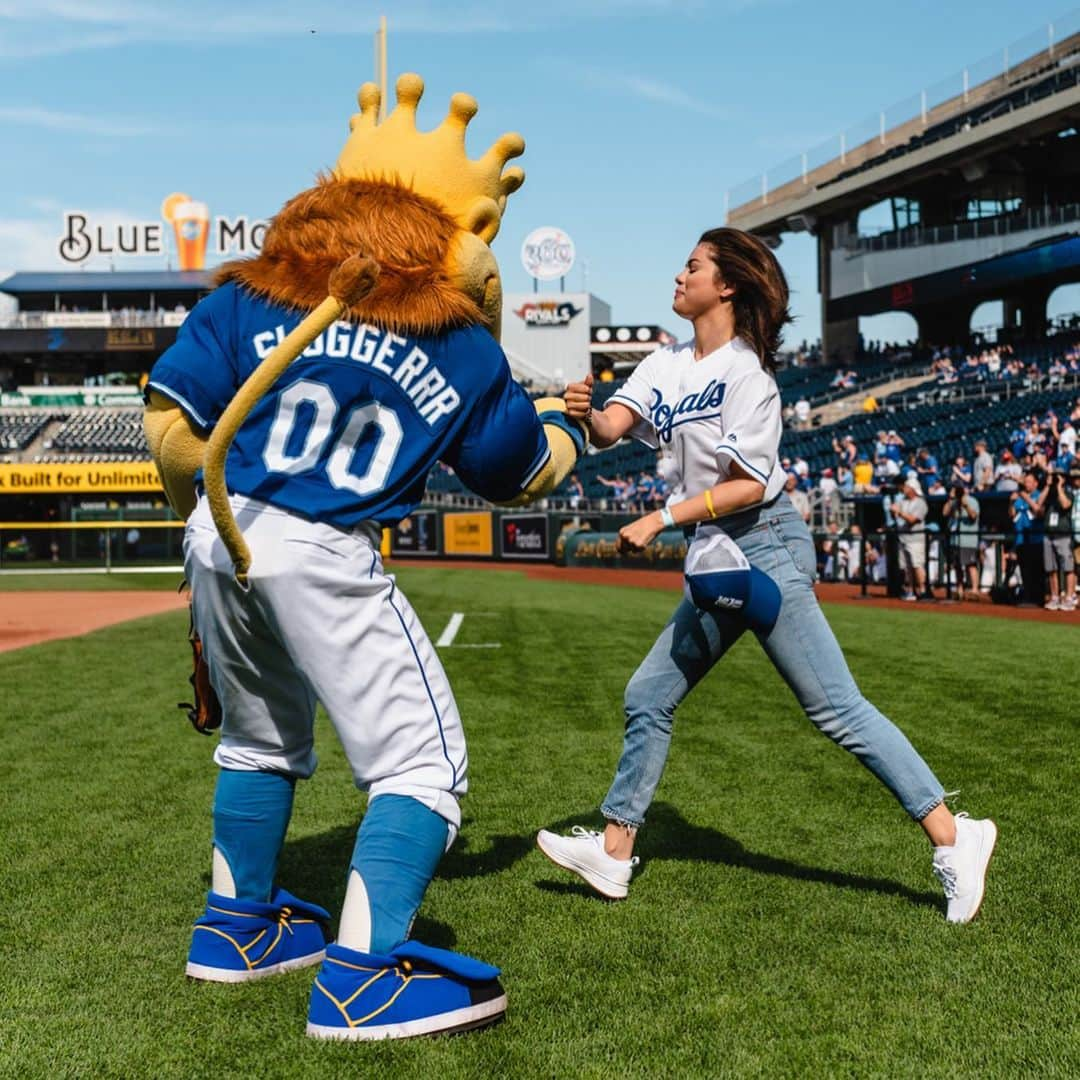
698 229 792 375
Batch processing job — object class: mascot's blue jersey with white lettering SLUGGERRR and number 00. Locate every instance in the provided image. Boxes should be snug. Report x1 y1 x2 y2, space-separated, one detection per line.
148 284 550 527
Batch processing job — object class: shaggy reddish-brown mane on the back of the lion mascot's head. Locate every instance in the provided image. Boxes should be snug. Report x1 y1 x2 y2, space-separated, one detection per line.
214 176 484 334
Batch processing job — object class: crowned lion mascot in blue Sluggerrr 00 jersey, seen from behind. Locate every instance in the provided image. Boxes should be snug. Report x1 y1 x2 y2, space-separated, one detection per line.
145 75 586 1039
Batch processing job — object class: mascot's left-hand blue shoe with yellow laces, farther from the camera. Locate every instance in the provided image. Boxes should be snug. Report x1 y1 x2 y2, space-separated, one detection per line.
187 889 330 983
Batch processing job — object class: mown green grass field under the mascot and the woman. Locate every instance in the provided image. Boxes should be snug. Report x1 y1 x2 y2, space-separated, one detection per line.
0 567 1080 1080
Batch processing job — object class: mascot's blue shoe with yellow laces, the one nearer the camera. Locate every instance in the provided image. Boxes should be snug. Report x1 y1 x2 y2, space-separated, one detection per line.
308 941 507 1039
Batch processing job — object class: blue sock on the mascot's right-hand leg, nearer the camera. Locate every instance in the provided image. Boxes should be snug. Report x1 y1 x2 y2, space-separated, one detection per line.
351 795 449 953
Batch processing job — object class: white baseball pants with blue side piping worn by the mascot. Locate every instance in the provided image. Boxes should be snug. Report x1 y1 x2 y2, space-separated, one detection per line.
184 496 468 829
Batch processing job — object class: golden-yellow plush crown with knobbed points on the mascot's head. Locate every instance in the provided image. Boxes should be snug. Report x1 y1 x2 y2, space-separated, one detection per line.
334 75 525 243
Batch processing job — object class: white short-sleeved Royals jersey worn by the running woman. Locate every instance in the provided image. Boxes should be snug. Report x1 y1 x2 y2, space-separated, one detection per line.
610 338 786 503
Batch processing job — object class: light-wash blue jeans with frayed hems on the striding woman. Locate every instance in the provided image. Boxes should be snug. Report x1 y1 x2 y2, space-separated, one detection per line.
600 495 944 827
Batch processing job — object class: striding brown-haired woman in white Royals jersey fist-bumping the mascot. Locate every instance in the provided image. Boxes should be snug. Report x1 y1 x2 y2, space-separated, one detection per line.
537 229 997 922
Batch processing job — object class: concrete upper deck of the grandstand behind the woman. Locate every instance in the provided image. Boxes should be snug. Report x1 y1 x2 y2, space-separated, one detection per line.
728 16 1080 363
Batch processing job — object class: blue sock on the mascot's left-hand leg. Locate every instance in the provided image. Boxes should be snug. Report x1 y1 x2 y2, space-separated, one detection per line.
214 769 296 904
